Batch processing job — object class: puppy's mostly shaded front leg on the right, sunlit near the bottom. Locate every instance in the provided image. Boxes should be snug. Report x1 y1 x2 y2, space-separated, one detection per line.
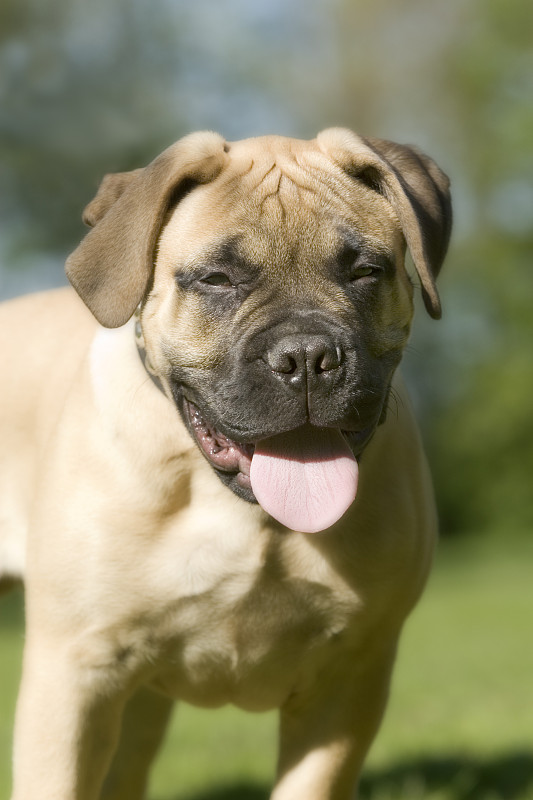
271 643 396 800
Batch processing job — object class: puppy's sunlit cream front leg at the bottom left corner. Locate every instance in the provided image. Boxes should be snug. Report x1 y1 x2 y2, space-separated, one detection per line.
12 639 127 800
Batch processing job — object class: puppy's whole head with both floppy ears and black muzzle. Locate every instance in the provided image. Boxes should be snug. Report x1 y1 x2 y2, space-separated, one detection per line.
67 129 451 527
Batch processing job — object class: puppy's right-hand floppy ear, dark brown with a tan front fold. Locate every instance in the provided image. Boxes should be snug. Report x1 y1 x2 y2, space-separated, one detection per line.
317 128 452 319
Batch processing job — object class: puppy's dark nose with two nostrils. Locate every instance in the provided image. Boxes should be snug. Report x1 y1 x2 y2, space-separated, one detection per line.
266 334 342 387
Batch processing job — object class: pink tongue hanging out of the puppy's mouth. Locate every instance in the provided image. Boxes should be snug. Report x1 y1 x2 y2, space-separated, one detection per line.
250 425 359 533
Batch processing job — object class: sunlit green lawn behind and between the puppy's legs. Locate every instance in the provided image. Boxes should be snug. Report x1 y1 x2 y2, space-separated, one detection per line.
0 533 533 800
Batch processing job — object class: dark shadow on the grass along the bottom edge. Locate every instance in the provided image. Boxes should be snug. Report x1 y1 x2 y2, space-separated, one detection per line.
160 752 533 800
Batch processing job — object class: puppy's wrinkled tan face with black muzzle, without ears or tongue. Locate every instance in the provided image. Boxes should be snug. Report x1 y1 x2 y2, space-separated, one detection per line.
142 141 412 499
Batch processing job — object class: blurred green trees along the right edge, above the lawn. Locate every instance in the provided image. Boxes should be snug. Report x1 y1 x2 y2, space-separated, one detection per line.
429 0 533 530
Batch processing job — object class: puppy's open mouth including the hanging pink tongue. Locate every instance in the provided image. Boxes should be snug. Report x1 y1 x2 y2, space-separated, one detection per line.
183 400 373 533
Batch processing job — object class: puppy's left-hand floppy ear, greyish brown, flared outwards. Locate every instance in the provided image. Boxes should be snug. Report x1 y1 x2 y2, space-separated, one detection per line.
66 132 227 328
